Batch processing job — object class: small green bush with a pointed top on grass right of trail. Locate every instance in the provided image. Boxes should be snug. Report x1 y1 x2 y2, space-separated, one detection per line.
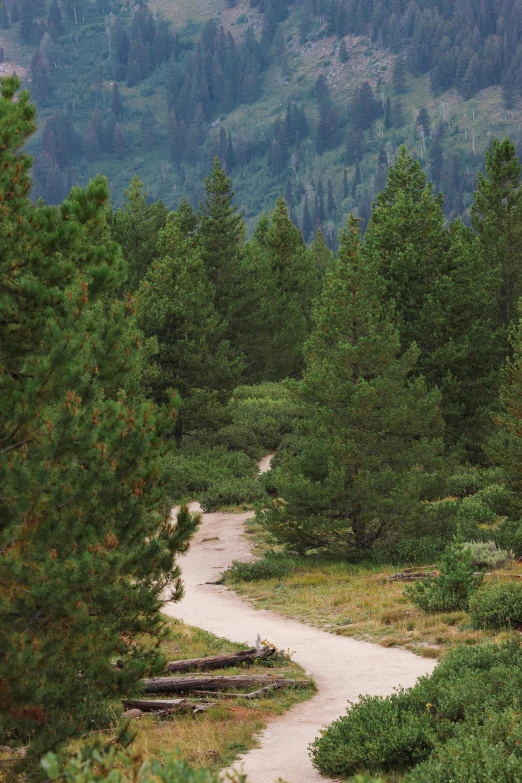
405 539 482 612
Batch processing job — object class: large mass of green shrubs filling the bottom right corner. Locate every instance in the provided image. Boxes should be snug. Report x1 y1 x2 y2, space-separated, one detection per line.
311 640 522 783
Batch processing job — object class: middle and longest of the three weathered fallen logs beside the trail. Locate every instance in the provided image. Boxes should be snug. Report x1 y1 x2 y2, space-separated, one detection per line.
142 674 311 693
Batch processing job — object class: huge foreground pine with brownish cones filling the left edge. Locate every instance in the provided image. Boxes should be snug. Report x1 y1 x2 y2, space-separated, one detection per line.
0 77 199 779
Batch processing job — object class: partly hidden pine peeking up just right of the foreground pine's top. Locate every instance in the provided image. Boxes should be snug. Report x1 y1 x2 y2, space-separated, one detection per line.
111 174 168 291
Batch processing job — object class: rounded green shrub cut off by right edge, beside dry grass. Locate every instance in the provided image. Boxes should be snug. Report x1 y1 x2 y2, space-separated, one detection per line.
469 582 522 628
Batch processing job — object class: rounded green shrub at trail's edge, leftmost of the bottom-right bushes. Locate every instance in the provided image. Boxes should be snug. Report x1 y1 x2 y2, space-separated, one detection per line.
310 694 433 776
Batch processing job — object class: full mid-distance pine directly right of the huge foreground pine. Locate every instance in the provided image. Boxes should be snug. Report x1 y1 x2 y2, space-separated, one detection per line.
136 208 242 442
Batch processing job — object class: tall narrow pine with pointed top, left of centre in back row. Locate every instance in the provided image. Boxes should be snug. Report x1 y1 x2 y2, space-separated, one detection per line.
199 158 245 330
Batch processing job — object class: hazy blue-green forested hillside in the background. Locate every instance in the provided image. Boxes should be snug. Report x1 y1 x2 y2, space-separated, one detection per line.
0 0 522 239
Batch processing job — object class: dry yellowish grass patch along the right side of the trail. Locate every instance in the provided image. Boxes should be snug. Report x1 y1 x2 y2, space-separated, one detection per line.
228 563 522 658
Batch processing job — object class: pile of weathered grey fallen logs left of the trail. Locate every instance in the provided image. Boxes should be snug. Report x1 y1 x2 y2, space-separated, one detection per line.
122 646 312 718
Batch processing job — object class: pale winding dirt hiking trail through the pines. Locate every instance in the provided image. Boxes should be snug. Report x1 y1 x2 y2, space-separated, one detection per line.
164 458 435 783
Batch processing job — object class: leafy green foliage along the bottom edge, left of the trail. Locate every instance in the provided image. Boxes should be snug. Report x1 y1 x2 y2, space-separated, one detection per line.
41 748 246 783
